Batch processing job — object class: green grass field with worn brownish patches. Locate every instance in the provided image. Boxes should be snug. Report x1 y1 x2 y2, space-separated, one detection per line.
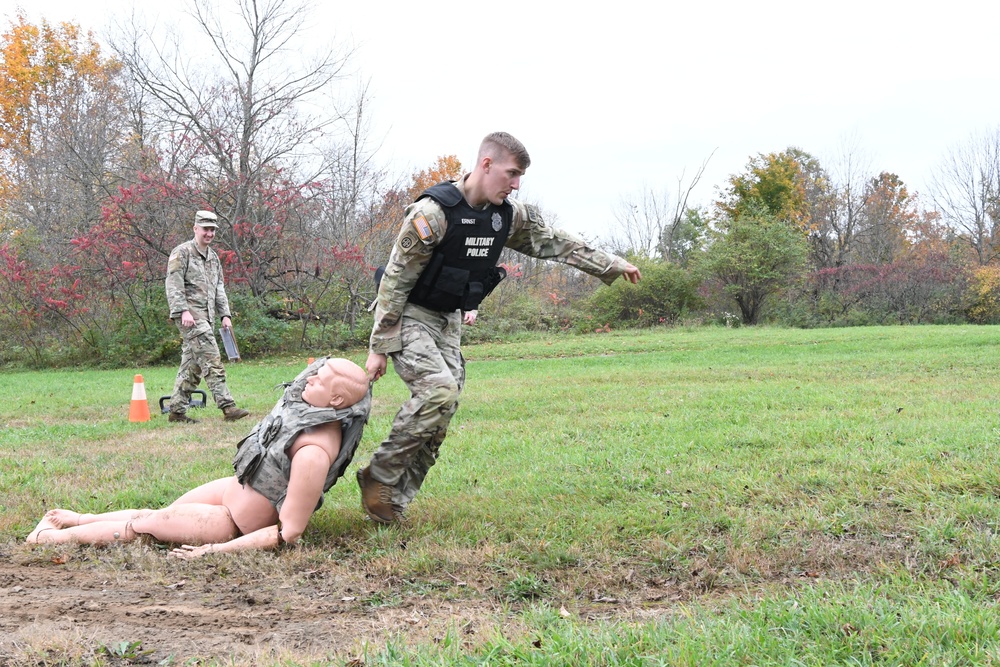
0 326 1000 665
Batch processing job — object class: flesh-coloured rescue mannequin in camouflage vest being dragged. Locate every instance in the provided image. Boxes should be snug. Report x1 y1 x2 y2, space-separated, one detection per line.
27 358 371 558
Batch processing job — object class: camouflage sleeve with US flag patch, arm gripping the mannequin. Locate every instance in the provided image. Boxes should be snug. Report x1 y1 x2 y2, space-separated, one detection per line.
370 198 448 354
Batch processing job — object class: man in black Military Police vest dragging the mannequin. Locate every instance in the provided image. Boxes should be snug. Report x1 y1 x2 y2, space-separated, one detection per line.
357 132 641 523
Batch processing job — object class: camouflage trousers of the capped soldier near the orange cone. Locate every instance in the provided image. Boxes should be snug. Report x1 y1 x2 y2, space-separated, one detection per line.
170 319 236 413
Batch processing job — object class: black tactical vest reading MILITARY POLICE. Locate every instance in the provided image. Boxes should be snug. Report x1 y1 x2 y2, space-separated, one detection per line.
409 181 514 312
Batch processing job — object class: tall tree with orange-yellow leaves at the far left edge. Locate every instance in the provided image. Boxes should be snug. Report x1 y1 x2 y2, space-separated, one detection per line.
0 16 141 363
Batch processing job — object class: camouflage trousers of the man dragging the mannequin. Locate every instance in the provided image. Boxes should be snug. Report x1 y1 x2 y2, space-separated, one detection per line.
370 304 465 507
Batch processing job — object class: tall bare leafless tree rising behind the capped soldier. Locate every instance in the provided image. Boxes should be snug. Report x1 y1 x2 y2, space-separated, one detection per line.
112 0 350 295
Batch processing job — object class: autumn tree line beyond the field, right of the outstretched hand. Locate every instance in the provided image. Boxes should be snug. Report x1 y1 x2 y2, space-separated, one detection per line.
596 136 1000 326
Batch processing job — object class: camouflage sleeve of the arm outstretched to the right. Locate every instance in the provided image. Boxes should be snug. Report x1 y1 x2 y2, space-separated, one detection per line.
506 199 628 285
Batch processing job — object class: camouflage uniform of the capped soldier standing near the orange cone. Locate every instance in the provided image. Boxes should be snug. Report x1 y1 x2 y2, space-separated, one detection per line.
166 239 236 414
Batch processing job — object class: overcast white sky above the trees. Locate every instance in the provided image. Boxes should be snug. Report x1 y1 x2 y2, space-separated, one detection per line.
7 0 1000 237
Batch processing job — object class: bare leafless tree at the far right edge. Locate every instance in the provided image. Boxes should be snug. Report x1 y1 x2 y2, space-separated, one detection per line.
931 128 1000 266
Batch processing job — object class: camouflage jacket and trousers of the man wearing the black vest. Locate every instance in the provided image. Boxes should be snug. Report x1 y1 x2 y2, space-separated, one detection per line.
369 176 628 508
